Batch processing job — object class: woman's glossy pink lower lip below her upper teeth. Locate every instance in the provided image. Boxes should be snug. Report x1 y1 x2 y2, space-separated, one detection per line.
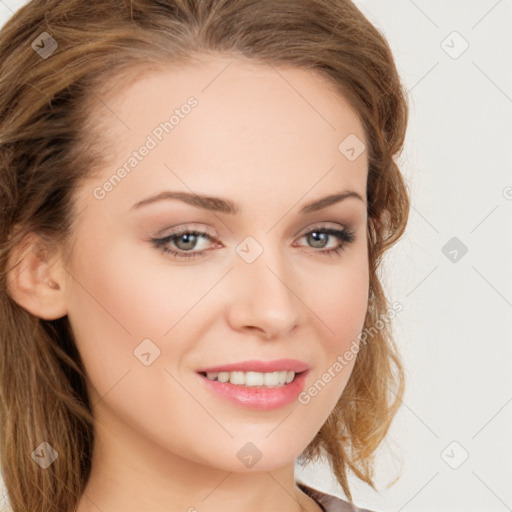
197 370 309 411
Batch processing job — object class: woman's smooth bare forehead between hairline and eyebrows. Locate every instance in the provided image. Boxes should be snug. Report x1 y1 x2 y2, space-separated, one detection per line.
76 56 367 215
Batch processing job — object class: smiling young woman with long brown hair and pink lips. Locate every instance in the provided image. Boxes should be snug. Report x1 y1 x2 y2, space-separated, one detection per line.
0 0 409 512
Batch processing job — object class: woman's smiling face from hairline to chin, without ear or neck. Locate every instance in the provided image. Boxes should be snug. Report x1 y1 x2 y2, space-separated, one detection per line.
65 57 368 472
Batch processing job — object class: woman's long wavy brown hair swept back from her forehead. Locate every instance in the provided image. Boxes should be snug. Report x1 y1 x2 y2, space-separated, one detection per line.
0 0 409 512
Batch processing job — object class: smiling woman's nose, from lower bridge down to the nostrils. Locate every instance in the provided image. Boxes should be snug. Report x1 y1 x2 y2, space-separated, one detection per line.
227 245 302 339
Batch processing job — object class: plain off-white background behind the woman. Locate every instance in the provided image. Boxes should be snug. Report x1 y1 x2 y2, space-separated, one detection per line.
0 0 512 512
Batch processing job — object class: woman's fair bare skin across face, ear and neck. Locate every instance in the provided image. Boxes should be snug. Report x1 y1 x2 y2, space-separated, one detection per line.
11 56 368 512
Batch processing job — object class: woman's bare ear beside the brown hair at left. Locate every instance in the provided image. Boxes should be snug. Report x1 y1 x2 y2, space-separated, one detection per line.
7 233 67 320
